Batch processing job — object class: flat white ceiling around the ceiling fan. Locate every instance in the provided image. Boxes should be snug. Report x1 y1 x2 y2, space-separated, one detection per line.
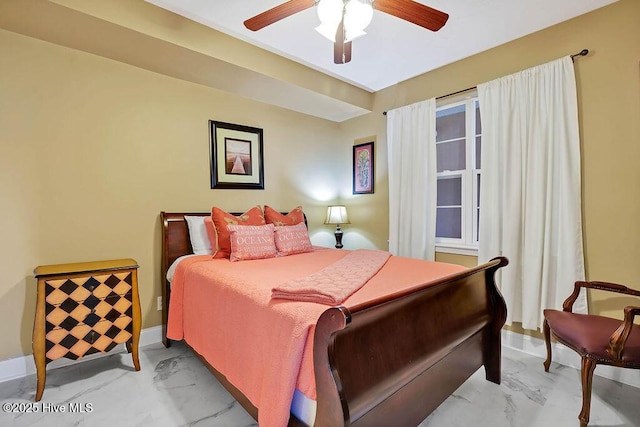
146 0 617 92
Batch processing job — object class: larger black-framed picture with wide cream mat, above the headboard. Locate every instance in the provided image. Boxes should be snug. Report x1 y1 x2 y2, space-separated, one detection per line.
209 120 264 190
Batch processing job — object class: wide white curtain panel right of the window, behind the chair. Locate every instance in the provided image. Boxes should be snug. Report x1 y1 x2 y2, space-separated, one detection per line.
478 56 587 330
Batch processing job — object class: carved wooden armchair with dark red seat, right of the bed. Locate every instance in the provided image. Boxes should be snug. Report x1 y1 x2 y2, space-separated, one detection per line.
544 282 640 427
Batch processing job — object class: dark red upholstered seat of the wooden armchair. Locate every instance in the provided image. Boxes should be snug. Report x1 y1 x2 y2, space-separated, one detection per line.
544 309 640 365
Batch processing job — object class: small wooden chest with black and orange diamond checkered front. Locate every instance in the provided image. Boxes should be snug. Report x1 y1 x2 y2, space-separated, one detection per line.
33 259 142 401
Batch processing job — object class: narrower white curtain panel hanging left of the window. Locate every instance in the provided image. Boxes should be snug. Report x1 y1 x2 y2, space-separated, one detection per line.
387 98 437 260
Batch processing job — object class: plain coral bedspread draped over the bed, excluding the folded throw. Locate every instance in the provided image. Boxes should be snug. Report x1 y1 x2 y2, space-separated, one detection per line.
167 249 464 427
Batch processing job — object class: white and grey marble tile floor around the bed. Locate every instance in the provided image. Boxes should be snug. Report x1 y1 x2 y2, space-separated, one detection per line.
0 343 640 427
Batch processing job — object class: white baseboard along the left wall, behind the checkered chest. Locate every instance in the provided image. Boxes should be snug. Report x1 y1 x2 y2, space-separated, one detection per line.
0 326 162 383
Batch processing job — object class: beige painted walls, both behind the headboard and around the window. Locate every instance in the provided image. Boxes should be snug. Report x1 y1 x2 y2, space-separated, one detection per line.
0 0 640 360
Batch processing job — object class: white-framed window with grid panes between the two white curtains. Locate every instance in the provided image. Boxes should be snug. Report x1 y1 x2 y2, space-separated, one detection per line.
436 95 482 254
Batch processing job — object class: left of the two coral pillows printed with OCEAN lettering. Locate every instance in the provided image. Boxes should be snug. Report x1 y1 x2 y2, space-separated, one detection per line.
227 224 277 261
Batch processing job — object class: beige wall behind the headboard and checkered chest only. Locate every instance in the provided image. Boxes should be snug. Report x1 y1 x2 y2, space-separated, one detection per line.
0 30 351 360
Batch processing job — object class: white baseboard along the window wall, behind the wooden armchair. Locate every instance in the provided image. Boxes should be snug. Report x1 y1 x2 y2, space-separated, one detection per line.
502 329 640 388
